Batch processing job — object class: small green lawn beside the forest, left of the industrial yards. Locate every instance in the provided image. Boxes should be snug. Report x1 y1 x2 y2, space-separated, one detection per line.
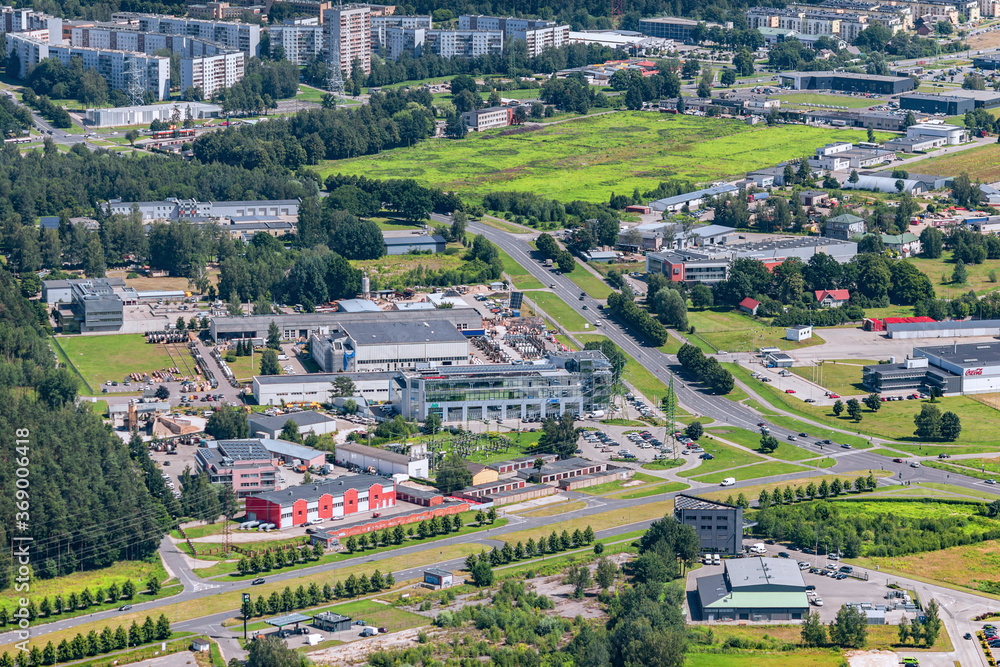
59 334 178 392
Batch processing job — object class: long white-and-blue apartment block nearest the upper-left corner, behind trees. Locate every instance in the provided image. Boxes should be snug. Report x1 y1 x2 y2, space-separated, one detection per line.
7 33 169 100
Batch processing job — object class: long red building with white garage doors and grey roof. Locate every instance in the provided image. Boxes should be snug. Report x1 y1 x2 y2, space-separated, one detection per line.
246 475 396 528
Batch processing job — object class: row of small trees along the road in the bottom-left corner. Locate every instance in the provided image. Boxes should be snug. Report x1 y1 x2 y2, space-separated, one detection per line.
0 614 172 667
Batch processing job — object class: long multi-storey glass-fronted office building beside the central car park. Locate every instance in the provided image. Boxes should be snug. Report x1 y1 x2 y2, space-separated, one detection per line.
389 350 611 422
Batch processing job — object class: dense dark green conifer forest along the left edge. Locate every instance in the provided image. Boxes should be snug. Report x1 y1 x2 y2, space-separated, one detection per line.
0 271 169 589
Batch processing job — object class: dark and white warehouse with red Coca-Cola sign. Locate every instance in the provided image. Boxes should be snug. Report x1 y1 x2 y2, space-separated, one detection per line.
862 344 1000 396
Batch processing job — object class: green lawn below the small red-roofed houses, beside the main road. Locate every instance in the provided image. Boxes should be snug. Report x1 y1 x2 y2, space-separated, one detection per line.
688 307 825 354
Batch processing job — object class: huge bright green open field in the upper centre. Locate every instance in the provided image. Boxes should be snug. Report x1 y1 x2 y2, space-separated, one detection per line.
318 112 892 201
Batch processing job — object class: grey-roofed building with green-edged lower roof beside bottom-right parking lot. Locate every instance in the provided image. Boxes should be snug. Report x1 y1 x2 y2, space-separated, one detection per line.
692 557 809 621
